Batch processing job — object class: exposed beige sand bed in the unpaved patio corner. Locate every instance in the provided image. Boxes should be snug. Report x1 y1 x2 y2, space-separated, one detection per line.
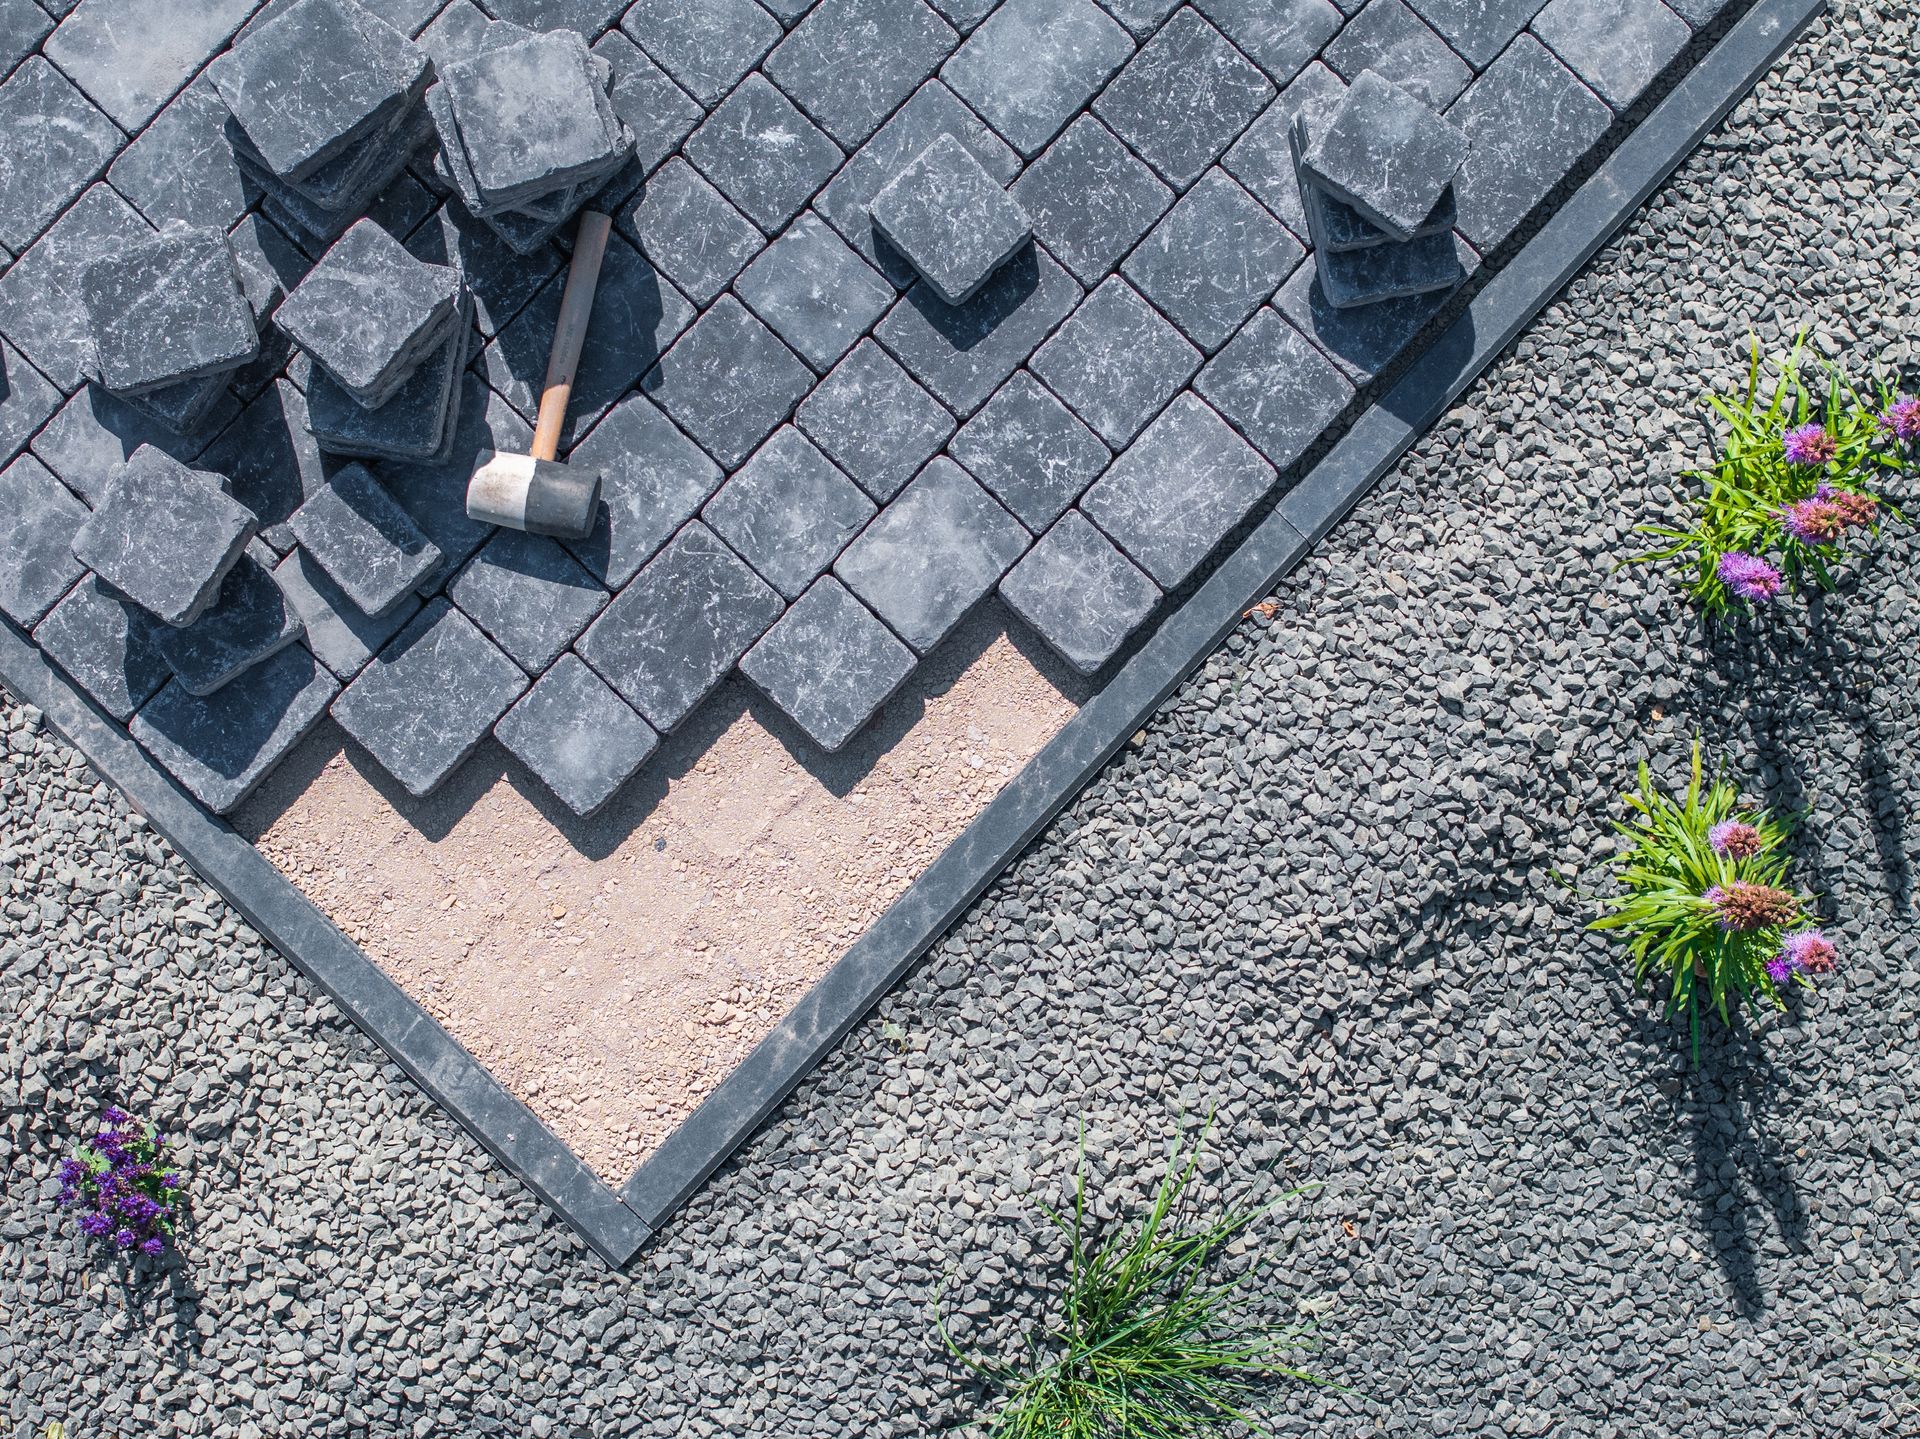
234 609 1083 1183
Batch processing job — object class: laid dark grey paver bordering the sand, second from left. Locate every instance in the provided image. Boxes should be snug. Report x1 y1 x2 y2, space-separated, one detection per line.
332 599 526 799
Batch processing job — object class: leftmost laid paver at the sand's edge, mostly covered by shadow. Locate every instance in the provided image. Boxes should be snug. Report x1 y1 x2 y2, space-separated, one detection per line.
129 646 340 815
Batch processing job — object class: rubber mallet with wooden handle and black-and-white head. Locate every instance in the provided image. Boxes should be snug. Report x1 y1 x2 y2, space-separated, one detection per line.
467 209 612 540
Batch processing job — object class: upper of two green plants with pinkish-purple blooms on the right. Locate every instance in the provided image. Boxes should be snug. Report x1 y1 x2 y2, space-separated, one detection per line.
1634 334 1920 615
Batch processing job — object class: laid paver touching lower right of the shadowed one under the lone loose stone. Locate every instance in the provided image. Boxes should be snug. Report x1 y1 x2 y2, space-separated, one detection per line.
1029 275 1200 448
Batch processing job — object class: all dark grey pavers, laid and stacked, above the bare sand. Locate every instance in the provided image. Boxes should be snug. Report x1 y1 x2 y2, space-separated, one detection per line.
0 0 1704 815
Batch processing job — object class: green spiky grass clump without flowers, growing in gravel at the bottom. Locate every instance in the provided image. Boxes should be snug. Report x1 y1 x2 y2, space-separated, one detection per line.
939 1122 1336 1439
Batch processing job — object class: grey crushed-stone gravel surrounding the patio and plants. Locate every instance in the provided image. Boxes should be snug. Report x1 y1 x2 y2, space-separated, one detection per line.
0 0 1920 1439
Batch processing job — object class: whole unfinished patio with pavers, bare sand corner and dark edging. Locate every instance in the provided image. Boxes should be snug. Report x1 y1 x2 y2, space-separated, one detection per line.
0 0 1818 1262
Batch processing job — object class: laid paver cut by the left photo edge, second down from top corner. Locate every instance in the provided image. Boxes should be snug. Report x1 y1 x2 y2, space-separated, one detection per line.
0 56 121 251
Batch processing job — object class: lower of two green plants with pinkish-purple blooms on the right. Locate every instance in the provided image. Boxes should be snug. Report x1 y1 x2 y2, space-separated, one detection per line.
1590 744 1839 1055
